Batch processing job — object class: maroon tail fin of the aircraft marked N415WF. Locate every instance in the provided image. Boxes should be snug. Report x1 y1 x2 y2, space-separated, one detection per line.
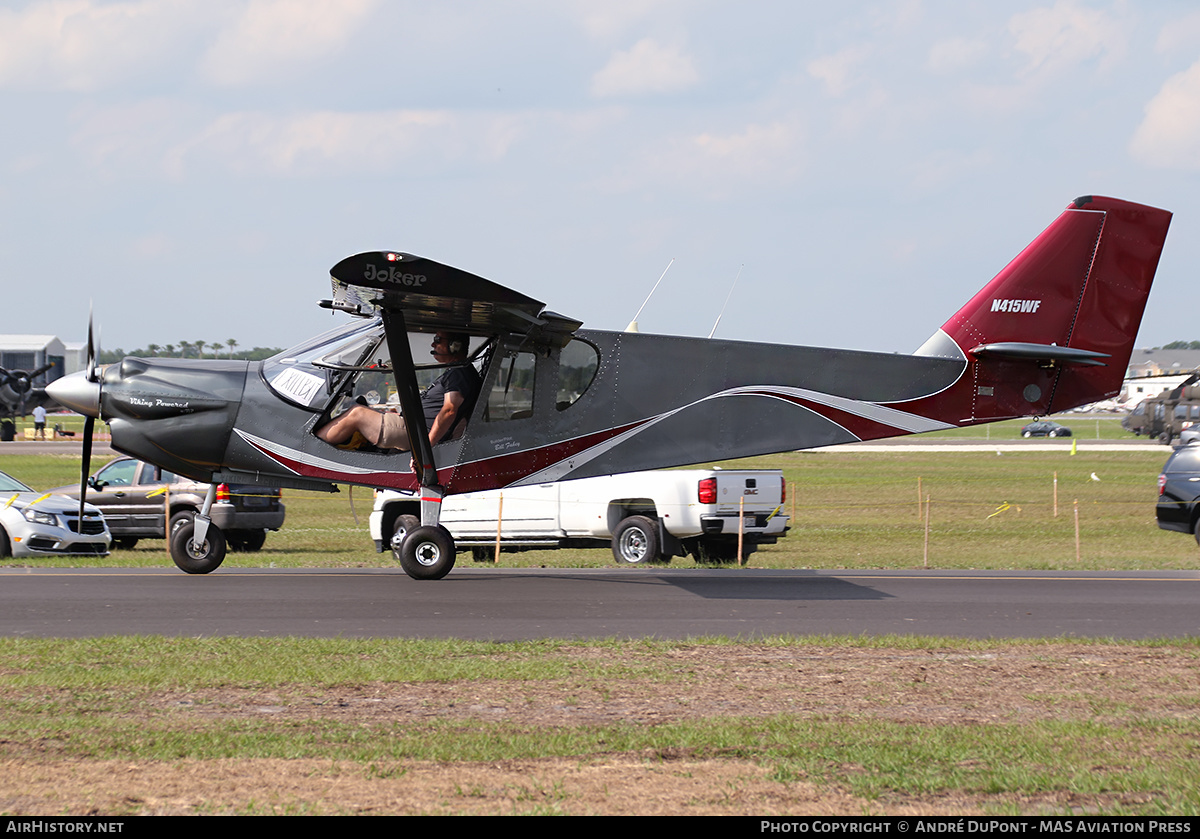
918 196 1171 423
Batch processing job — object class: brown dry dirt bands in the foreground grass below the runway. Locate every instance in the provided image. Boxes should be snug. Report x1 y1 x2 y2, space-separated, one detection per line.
0 643 1200 815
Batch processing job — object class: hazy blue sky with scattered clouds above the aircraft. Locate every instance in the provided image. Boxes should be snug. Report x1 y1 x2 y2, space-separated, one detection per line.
0 0 1200 353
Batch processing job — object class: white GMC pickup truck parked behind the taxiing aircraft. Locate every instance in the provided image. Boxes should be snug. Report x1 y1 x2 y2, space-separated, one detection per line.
371 469 787 564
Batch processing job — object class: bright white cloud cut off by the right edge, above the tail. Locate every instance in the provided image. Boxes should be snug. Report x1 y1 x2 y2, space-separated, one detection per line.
1129 61 1200 172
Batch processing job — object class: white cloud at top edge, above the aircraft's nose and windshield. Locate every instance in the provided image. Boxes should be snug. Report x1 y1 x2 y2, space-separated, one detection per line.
202 0 377 85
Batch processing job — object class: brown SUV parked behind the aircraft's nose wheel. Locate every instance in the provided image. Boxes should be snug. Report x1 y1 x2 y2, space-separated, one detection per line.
50 457 284 551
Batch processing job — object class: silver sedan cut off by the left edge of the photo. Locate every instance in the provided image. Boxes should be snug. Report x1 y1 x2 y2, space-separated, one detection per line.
0 472 112 557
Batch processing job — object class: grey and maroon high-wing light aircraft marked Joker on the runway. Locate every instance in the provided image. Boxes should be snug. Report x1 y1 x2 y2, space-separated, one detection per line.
49 196 1171 579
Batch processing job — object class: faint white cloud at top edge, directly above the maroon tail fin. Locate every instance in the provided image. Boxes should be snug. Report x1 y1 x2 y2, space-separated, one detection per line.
1008 0 1126 73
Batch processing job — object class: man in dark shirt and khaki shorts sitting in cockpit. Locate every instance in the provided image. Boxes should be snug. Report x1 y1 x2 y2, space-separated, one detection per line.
317 330 480 451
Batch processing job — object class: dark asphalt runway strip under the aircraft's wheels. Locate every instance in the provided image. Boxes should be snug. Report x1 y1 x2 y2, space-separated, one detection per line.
0 568 1200 641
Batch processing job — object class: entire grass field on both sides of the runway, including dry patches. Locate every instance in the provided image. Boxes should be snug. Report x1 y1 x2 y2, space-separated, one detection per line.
0 432 1200 815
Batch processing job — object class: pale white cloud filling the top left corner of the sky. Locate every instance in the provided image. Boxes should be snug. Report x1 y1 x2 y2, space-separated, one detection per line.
0 0 196 92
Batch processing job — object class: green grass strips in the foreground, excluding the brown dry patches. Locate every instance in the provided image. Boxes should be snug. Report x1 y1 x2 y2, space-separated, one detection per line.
0 637 1200 815
